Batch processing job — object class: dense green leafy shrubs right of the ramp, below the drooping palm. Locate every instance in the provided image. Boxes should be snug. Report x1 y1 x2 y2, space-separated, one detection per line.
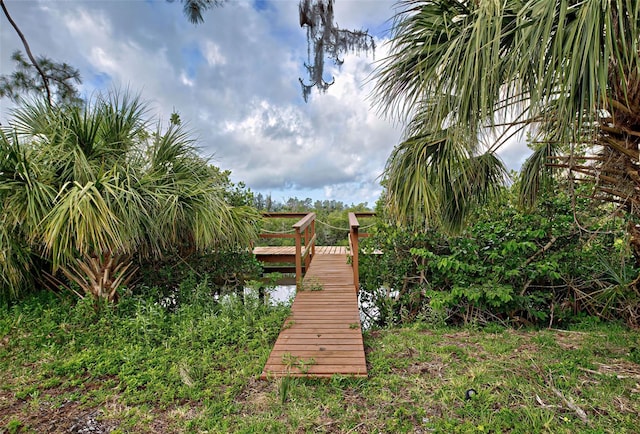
360 185 640 325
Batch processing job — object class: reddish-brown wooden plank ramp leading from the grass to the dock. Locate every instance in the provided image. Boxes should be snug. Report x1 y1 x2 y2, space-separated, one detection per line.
261 253 367 379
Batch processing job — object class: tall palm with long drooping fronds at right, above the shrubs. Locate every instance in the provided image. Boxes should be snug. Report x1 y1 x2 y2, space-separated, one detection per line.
376 0 640 244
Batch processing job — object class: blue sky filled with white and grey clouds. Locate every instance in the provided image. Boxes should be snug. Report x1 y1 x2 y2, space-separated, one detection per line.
0 0 523 206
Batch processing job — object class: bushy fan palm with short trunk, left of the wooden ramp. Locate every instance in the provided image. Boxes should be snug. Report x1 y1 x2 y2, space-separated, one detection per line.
0 93 257 301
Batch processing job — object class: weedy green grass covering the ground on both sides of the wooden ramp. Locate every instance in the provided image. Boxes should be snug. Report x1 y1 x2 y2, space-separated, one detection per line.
0 288 640 433
